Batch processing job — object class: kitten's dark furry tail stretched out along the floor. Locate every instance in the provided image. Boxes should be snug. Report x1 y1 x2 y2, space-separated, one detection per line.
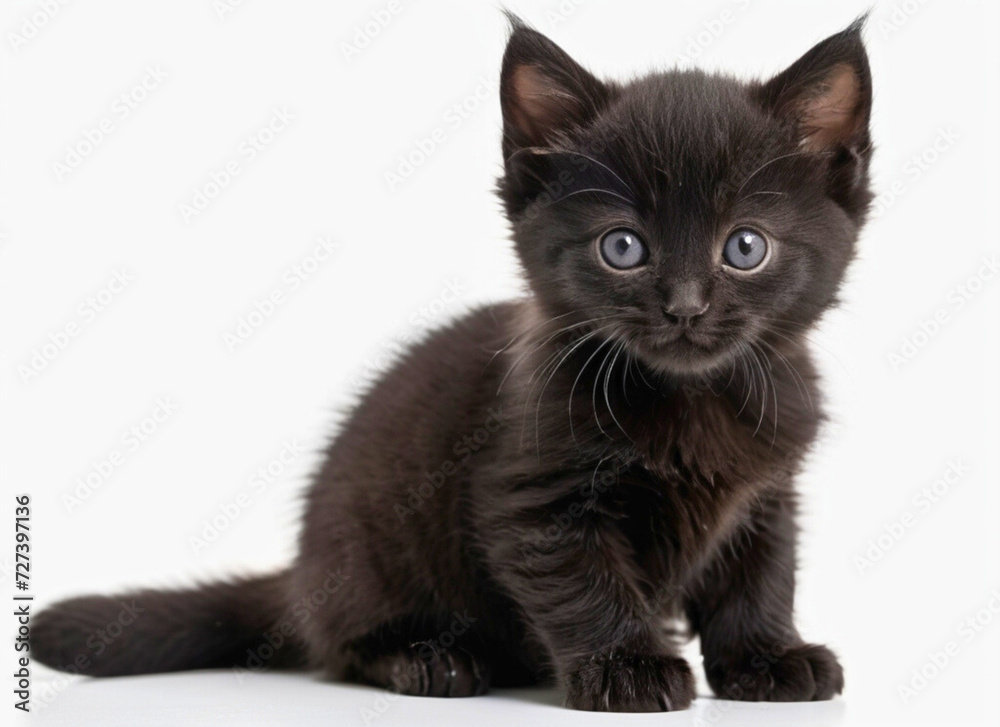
29 572 306 676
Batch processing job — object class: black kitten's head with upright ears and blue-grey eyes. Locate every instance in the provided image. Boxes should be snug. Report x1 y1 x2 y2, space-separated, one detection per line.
500 14 872 375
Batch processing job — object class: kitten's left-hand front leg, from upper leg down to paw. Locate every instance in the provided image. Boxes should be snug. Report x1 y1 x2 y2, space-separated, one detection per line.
490 486 694 712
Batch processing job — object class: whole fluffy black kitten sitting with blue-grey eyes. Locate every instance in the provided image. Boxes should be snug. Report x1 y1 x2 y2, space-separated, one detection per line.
31 14 872 711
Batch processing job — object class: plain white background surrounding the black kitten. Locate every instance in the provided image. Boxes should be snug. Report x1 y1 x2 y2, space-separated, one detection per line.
0 0 1000 725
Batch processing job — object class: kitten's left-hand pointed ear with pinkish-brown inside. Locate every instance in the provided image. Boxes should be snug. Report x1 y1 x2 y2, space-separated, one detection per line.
500 14 609 159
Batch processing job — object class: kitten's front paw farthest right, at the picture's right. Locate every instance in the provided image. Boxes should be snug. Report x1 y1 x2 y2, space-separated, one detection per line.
705 644 844 702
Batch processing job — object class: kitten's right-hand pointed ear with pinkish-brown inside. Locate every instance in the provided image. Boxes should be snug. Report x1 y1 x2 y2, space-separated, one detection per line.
760 15 872 155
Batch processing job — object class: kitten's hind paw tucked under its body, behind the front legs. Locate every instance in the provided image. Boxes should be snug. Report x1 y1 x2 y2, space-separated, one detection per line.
344 619 491 697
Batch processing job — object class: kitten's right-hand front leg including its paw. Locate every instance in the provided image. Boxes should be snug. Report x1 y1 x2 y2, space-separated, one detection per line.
687 486 844 702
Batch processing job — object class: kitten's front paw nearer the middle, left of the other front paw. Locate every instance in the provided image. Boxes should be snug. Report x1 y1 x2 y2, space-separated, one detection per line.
566 655 694 712
